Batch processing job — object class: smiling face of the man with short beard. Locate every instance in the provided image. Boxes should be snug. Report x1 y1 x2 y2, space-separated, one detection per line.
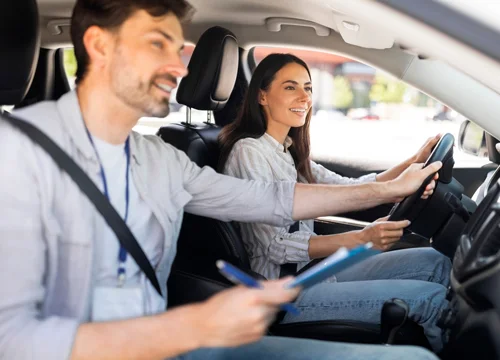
107 10 187 117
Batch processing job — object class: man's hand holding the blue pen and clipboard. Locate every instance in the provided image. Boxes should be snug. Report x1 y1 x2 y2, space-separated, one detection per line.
193 277 300 347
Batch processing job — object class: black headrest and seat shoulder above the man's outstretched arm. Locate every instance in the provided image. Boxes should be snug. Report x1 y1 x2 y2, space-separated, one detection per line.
158 26 239 168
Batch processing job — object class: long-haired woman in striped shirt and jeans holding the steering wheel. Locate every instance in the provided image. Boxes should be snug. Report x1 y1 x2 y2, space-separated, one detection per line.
219 54 451 348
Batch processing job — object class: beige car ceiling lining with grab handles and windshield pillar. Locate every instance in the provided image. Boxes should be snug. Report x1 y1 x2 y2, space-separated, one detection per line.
29 0 500 138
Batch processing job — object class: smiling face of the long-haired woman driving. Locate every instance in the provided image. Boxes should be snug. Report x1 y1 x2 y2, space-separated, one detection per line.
259 63 312 127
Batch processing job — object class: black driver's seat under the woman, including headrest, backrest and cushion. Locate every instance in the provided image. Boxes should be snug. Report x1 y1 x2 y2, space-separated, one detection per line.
159 28 426 352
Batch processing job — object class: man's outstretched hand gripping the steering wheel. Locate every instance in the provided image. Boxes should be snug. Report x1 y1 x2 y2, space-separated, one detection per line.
389 161 443 202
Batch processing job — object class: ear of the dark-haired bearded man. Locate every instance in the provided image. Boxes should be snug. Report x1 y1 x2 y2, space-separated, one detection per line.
83 26 112 73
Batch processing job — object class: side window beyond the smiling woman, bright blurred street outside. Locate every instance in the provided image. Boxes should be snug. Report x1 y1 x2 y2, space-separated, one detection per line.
253 46 488 170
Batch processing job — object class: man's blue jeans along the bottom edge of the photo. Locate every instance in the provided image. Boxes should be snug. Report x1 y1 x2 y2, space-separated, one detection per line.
180 337 437 360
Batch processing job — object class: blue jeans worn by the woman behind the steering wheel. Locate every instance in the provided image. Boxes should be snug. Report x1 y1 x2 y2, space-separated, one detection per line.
283 248 451 351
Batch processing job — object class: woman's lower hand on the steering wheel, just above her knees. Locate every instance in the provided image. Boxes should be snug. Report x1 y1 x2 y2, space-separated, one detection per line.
359 216 410 250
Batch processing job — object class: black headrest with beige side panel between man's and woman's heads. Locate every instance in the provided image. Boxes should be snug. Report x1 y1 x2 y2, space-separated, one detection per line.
177 26 239 110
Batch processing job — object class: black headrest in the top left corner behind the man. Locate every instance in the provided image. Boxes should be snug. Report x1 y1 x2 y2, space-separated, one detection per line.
0 0 40 105
